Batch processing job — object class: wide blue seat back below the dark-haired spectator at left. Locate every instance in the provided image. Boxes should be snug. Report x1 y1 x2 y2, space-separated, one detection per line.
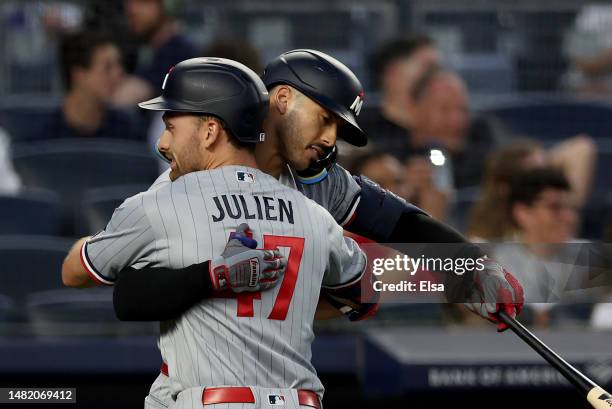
13 139 159 203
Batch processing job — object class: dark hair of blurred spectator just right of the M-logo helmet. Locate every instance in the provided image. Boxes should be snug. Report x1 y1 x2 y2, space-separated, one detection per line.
372 34 435 85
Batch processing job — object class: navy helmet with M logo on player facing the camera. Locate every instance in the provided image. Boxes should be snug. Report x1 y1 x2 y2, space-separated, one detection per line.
263 49 368 146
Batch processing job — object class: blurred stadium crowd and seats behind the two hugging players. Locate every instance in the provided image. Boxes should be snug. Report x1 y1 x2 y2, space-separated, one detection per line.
0 0 612 406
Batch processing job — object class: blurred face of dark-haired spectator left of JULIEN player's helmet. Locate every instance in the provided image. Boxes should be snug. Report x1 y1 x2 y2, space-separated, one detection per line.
62 90 106 133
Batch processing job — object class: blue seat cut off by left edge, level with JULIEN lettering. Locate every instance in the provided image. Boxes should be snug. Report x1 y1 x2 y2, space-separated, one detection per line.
0 189 62 236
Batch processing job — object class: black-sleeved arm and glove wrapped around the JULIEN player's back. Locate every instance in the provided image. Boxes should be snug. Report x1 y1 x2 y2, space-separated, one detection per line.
113 224 287 321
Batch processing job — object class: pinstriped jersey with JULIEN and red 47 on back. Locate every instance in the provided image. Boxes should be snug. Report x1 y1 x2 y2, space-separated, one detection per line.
82 166 365 395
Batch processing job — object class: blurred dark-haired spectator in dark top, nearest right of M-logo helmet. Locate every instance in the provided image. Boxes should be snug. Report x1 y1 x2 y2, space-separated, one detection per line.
359 35 440 151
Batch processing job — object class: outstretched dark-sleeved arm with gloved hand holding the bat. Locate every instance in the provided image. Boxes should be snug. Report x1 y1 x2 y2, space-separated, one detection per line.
344 176 524 329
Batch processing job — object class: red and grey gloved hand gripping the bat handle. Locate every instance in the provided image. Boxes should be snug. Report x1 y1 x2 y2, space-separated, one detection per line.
465 259 525 332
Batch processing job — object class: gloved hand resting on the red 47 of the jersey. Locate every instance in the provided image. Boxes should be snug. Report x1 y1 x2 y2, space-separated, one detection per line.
210 223 287 293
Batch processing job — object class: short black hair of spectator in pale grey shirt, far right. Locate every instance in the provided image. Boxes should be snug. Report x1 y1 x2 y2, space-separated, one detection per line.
509 166 570 208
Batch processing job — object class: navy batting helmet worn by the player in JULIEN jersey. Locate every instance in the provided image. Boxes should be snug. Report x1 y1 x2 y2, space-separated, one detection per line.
143 57 269 143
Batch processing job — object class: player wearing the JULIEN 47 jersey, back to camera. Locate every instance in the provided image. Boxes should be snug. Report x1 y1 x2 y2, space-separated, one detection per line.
62 58 366 408
